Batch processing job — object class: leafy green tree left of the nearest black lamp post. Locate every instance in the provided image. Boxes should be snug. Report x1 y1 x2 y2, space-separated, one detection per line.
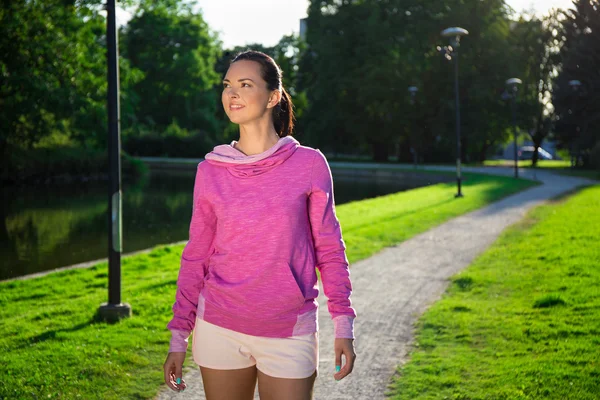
0 0 106 155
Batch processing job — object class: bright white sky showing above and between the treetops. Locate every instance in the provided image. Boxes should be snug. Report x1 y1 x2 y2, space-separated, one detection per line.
117 0 572 48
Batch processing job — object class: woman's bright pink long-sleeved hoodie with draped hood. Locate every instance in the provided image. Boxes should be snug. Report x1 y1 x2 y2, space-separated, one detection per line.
167 136 356 351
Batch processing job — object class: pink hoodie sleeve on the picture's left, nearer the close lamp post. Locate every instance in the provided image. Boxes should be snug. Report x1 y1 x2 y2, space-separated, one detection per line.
167 164 217 352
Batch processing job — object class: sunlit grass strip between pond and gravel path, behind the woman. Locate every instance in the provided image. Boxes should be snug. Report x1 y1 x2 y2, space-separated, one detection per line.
0 174 536 400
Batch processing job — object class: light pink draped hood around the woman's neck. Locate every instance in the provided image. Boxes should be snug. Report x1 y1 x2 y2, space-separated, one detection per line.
204 136 300 178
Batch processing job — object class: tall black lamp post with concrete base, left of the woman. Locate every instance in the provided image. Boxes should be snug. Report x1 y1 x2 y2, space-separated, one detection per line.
98 0 131 322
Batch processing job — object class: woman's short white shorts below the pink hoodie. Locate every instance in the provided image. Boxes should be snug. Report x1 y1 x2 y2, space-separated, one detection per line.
192 318 319 379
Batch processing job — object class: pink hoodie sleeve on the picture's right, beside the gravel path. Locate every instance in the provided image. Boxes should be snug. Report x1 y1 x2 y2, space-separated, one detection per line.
308 150 356 339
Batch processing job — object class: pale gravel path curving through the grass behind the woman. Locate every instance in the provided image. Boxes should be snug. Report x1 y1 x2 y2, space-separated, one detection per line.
156 167 598 400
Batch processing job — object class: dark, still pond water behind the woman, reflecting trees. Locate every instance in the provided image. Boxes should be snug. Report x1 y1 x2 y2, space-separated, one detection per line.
0 169 450 280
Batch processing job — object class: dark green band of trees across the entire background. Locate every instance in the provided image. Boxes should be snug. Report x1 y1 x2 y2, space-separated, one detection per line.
0 0 600 176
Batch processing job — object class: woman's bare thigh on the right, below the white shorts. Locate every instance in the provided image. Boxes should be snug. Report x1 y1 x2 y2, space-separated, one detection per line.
258 371 317 400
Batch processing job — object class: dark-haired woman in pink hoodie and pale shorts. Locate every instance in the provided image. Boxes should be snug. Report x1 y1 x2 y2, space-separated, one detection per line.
164 51 356 400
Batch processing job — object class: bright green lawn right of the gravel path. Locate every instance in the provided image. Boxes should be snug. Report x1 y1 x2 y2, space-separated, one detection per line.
391 185 600 400
